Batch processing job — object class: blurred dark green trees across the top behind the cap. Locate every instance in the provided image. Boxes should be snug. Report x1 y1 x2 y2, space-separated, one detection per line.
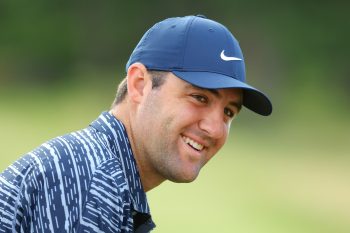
0 0 350 104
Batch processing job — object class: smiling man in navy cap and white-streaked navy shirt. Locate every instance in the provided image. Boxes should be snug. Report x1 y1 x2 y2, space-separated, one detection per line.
0 16 272 232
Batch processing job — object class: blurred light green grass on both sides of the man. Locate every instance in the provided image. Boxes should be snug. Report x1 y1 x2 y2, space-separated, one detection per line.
0 80 350 233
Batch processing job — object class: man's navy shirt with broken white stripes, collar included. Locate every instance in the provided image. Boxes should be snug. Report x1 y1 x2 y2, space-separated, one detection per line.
0 112 154 233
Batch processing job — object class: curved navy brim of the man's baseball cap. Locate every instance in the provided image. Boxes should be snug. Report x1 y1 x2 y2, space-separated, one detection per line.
172 71 272 116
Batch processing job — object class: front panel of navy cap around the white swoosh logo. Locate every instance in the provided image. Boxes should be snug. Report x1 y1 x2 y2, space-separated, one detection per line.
183 17 245 80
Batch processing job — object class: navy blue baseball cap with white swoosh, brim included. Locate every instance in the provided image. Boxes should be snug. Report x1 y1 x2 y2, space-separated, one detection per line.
126 15 272 116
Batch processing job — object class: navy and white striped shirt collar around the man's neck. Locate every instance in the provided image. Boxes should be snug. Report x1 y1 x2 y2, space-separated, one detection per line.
90 112 150 214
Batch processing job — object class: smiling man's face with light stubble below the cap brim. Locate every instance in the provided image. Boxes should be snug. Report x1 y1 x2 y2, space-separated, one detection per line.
133 73 242 182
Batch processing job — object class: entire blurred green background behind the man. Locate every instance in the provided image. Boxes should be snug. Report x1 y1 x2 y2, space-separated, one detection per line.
0 0 350 233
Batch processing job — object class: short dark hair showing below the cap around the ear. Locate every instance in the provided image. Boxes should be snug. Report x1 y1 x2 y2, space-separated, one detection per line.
112 70 168 107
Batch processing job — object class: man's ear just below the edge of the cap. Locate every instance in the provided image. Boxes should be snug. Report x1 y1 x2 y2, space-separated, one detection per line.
127 63 152 103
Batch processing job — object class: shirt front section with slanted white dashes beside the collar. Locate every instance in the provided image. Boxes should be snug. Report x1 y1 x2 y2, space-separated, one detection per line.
77 170 129 233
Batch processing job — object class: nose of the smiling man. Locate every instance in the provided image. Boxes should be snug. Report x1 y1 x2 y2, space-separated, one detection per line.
199 109 228 139
